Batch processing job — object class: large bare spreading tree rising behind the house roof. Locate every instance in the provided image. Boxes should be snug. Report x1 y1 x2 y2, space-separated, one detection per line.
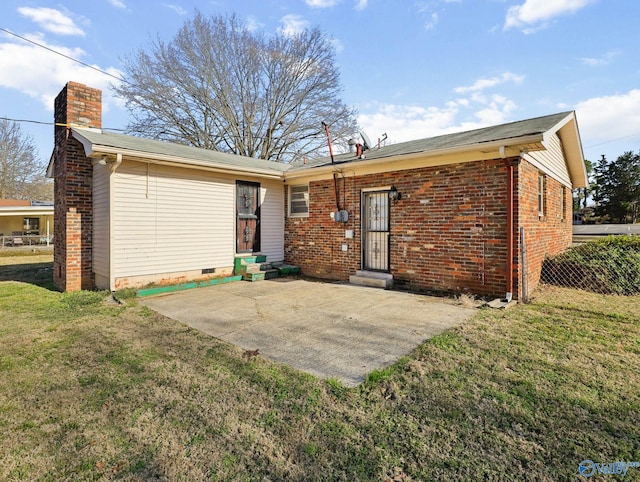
114 13 356 162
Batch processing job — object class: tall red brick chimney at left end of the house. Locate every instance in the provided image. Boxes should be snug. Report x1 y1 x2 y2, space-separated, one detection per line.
53 82 102 291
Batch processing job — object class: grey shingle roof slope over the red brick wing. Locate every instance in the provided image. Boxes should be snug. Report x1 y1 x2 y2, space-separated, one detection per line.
291 111 572 171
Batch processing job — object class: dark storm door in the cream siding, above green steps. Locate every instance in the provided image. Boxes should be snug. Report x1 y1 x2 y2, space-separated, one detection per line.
236 181 260 253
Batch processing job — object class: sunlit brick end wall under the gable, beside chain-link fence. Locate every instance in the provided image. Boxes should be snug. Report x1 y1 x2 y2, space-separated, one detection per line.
514 160 573 298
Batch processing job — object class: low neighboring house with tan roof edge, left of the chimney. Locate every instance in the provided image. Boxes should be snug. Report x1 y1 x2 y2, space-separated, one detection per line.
0 199 53 246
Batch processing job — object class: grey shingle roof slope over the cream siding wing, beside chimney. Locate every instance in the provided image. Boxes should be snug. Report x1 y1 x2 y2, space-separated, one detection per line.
73 128 289 173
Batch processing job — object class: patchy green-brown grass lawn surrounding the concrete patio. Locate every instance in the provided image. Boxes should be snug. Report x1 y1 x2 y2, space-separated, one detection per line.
0 257 640 481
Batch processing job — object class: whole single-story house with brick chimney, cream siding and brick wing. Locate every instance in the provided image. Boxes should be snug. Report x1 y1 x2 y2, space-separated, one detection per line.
49 82 586 298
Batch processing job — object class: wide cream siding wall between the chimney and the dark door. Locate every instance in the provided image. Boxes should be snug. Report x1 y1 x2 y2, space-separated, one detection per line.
114 162 235 278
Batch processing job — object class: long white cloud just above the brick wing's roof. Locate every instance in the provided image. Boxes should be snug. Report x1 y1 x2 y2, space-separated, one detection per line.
358 90 516 143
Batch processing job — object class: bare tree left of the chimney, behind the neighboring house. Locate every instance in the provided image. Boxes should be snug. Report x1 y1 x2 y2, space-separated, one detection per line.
0 119 53 200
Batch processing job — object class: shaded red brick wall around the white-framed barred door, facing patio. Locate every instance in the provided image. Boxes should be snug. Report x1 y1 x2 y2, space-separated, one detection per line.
285 159 507 296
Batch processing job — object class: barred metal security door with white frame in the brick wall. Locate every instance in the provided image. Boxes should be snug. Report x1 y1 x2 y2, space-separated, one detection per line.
362 191 390 271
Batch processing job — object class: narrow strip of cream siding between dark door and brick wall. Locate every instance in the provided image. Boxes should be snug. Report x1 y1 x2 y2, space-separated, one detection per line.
260 180 284 261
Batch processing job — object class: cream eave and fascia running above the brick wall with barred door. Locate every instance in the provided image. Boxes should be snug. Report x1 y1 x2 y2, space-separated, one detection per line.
283 134 544 180
